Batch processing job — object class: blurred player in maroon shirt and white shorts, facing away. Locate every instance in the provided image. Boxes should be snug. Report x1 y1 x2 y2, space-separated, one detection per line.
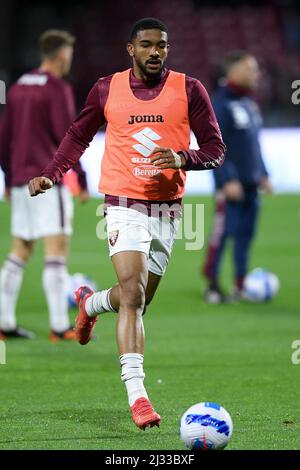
0 30 88 341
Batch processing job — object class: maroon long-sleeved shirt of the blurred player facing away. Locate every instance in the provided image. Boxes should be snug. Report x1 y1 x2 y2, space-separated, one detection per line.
0 69 86 189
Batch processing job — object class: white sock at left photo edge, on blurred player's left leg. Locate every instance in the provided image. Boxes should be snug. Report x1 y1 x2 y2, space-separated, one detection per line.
0 253 25 331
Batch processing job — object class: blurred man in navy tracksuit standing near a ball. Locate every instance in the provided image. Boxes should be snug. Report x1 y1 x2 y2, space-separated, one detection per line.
203 51 272 303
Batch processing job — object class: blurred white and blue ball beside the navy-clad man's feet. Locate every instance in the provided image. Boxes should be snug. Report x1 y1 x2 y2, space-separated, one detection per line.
243 268 279 302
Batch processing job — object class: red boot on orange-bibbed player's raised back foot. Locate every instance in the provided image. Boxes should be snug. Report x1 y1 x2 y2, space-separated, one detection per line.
74 286 98 344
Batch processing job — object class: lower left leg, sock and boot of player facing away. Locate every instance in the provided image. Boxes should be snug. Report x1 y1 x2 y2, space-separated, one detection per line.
0 237 35 339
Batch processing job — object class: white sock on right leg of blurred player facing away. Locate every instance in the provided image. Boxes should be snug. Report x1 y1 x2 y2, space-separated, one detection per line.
43 256 70 333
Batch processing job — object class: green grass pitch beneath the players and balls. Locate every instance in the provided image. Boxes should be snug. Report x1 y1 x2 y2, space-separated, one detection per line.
0 195 300 450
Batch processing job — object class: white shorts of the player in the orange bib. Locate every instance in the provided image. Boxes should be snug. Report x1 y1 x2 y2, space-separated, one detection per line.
106 206 180 276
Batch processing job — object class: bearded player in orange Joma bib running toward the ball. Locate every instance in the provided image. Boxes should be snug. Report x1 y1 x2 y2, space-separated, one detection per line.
29 18 225 429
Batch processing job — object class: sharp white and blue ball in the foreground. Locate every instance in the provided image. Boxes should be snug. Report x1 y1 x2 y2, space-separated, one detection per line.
180 402 233 450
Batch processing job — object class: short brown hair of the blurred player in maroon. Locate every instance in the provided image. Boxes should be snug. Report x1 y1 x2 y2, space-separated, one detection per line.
39 29 75 58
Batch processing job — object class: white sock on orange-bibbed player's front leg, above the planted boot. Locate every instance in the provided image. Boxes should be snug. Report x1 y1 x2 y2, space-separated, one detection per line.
120 353 148 406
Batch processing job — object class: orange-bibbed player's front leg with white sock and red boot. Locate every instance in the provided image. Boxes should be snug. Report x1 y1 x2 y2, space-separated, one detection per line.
112 251 160 429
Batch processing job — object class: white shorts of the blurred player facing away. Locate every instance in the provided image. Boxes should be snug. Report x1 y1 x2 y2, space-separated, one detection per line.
11 185 74 241
